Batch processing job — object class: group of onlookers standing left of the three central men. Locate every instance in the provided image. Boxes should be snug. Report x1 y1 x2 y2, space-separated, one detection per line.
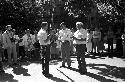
0 25 38 72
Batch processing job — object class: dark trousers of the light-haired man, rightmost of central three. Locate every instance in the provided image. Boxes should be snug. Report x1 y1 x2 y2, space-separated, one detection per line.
76 44 87 72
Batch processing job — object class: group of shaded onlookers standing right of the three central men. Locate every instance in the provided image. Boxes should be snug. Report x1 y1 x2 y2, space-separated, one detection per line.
87 27 124 57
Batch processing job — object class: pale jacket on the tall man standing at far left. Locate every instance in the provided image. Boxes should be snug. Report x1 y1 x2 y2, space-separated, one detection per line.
3 31 12 49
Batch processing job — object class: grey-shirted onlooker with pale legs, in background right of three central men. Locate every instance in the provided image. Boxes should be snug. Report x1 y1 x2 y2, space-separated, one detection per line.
93 28 101 53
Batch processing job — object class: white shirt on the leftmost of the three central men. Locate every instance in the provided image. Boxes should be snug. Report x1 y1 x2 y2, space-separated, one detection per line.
37 29 50 45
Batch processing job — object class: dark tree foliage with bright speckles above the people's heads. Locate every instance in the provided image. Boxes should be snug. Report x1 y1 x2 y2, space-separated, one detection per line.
0 0 125 32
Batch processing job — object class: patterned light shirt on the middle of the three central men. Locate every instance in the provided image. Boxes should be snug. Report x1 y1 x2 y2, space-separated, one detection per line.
58 28 72 42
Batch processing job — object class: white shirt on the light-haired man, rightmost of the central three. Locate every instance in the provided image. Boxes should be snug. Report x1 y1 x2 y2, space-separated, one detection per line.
73 28 87 44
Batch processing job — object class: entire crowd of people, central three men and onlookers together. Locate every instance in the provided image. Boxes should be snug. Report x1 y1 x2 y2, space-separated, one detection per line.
0 22 125 77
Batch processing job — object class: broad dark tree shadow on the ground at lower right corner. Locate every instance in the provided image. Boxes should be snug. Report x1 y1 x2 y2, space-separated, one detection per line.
87 64 125 81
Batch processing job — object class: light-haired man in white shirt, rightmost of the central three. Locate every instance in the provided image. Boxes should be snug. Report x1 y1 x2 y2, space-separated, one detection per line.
72 22 87 74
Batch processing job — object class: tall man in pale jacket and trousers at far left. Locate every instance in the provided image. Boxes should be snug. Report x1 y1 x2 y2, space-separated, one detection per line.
3 25 17 66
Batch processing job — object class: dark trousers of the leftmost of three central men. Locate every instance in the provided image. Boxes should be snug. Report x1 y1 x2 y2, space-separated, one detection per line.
42 45 50 74
